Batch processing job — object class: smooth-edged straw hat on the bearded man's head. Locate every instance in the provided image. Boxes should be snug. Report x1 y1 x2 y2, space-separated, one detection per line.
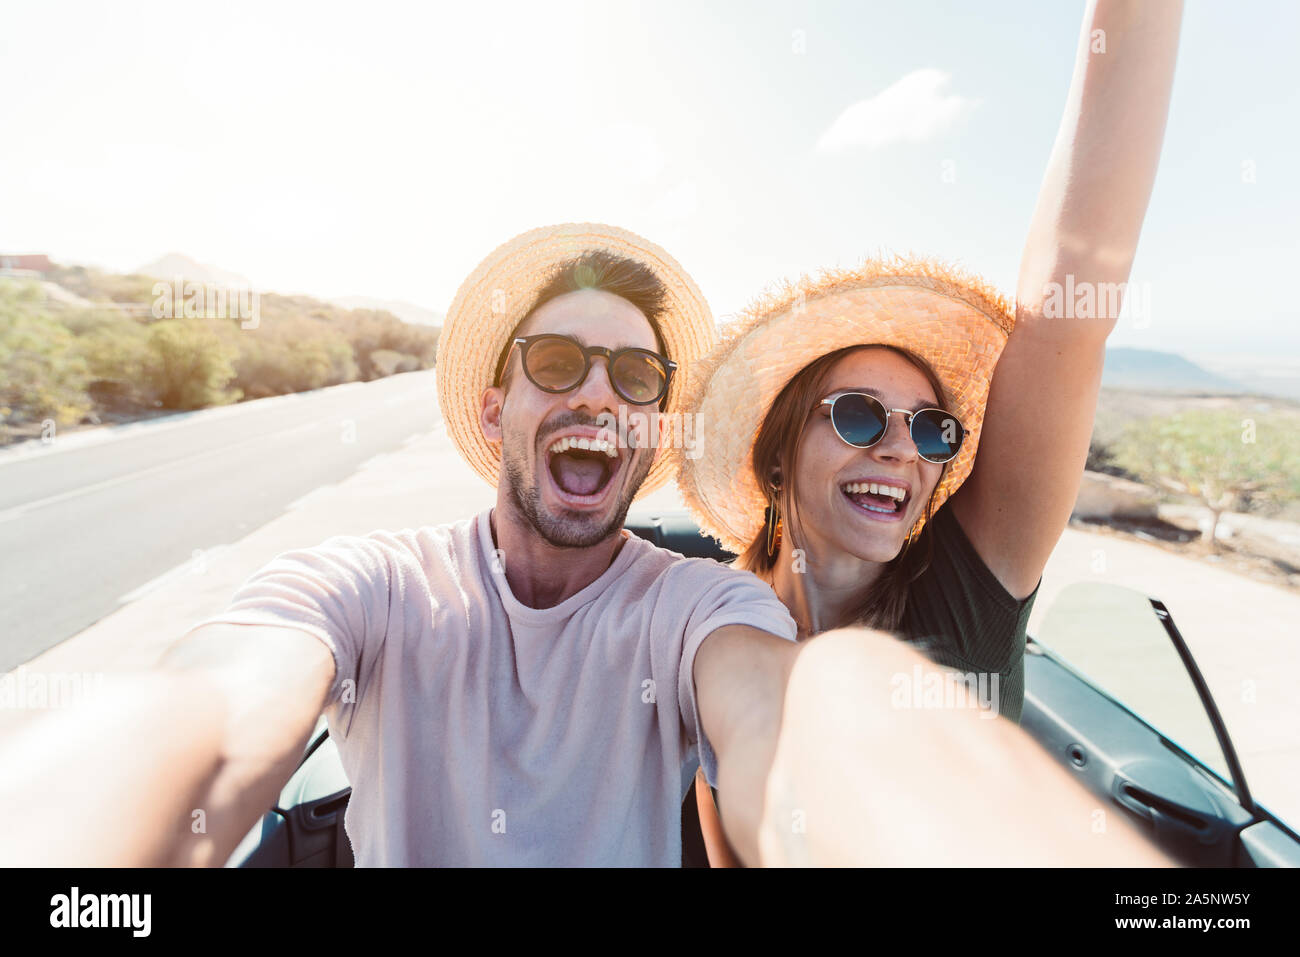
437 222 716 497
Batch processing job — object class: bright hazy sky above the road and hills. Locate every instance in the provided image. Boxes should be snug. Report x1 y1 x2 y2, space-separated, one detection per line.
0 0 1300 369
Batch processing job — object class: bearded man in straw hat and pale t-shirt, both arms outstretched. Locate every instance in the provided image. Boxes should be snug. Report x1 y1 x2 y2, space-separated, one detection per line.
0 225 1162 866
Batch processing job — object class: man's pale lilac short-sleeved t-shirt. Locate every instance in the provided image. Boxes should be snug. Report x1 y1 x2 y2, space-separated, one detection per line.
197 511 796 867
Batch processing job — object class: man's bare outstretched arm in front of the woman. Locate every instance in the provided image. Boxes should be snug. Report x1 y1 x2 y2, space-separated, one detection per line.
694 625 1170 867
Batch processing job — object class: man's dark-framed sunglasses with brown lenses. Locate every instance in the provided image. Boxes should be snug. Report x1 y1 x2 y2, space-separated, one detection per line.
497 333 677 406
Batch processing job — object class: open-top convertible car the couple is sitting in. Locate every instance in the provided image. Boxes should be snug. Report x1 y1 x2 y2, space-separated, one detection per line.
226 511 1300 867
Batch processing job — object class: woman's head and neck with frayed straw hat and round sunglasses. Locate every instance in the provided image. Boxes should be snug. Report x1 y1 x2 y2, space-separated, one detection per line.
680 259 1023 637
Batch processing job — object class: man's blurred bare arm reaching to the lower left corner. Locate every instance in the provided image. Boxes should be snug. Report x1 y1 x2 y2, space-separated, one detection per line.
0 625 334 867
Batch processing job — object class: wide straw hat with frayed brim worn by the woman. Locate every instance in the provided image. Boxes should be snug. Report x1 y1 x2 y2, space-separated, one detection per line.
675 256 1015 554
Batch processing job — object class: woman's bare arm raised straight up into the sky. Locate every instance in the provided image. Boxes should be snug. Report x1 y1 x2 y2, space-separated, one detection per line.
953 0 1182 598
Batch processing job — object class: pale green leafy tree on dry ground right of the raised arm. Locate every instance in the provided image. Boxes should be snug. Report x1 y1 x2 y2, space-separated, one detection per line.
1113 410 1300 549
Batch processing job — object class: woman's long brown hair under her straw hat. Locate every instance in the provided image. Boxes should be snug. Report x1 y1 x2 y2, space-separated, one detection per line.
735 345 952 631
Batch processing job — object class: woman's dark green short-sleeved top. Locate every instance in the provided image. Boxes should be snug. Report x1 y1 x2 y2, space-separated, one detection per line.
898 503 1039 723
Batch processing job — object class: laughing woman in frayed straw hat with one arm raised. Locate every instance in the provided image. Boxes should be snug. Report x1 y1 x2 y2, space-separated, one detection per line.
679 0 1180 866
